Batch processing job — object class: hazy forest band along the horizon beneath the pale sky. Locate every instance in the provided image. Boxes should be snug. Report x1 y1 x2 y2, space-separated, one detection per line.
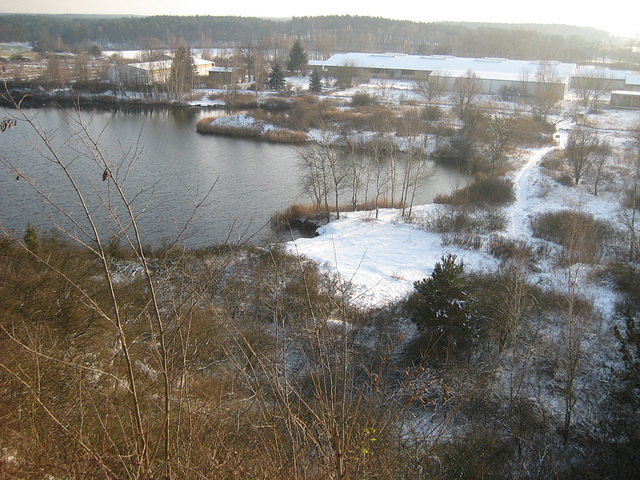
0 14 633 62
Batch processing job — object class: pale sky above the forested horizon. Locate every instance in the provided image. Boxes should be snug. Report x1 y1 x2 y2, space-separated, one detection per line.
0 0 640 37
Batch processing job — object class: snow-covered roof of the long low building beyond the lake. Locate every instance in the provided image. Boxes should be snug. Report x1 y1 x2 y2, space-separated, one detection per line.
309 52 576 79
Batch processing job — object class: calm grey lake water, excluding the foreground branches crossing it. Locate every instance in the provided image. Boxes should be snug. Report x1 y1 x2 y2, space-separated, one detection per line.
0 108 460 247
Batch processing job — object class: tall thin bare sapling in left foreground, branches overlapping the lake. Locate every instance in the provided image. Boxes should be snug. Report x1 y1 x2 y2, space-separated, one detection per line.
0 95 220 478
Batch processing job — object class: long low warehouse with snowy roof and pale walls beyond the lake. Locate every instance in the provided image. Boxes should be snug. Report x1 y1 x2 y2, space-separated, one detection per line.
309 52 576 98
